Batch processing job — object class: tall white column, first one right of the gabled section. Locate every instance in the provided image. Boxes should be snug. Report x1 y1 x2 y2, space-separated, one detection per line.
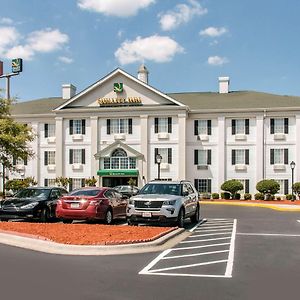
218 117 227 189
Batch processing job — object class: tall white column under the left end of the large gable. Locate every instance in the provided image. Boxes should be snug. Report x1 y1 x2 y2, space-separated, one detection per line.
55 117 63 177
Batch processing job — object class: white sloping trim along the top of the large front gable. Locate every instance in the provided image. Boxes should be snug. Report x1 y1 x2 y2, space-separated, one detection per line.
55 68 185 111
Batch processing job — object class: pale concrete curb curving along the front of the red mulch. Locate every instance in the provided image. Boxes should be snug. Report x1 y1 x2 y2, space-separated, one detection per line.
0 228 190 255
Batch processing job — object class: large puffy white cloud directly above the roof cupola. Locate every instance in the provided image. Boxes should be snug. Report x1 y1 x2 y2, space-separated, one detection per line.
115 35 184 65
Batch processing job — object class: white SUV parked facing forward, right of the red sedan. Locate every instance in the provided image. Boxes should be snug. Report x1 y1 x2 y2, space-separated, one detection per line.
127 181 200 227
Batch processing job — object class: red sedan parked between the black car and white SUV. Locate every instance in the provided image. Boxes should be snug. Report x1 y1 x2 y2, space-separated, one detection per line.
56 187 127 224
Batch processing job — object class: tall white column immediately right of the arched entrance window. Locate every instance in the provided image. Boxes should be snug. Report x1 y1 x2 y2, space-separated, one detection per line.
138 115 150 186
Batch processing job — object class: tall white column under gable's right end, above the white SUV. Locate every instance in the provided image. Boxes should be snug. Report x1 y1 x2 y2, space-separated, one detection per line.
178 114 188 180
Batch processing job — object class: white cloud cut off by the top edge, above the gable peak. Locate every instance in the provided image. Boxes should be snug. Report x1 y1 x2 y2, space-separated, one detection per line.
77 0 155 17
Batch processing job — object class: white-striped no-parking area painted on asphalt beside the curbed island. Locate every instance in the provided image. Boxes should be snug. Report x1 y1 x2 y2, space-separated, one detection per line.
139 219 237 278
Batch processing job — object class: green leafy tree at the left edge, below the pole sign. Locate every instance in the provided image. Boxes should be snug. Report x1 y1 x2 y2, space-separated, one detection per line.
0 97 34 195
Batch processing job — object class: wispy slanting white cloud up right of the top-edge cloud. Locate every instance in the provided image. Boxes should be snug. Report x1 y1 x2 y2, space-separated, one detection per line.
159 0 207 31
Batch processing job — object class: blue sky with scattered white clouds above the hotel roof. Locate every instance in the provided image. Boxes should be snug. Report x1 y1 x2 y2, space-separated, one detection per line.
0 0 300 101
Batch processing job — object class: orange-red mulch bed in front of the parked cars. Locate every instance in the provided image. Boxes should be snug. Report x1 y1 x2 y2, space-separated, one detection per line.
0 222 176 245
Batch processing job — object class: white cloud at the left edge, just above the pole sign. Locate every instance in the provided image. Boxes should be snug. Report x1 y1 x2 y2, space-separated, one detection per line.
0 27 69 60
